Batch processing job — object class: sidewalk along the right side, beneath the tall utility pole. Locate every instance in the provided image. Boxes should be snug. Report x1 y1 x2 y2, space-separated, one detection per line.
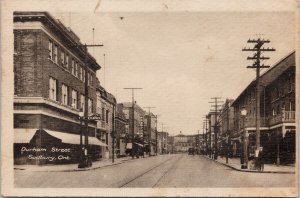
205 156 295 174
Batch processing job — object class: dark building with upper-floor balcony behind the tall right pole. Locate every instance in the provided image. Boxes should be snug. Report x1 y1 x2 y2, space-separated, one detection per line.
232 52 296 163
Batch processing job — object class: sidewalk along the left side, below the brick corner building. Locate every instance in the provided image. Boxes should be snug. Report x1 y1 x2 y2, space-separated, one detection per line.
14 156 155 172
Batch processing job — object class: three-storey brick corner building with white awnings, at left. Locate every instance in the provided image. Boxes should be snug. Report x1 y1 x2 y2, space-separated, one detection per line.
14 12 104 164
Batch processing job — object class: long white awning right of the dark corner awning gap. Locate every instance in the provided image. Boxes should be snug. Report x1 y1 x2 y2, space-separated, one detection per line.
45 130 107 147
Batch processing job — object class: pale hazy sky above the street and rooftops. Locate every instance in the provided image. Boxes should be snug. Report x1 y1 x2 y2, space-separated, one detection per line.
50 11 295 135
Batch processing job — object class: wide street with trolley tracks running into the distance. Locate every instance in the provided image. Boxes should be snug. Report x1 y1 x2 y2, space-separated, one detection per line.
15 154 294 188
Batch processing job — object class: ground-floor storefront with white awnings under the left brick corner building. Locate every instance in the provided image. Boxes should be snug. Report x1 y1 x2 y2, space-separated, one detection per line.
14 128 107 165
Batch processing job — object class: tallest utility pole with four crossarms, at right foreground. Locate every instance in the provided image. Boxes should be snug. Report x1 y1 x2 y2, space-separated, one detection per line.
242 38 275 166
